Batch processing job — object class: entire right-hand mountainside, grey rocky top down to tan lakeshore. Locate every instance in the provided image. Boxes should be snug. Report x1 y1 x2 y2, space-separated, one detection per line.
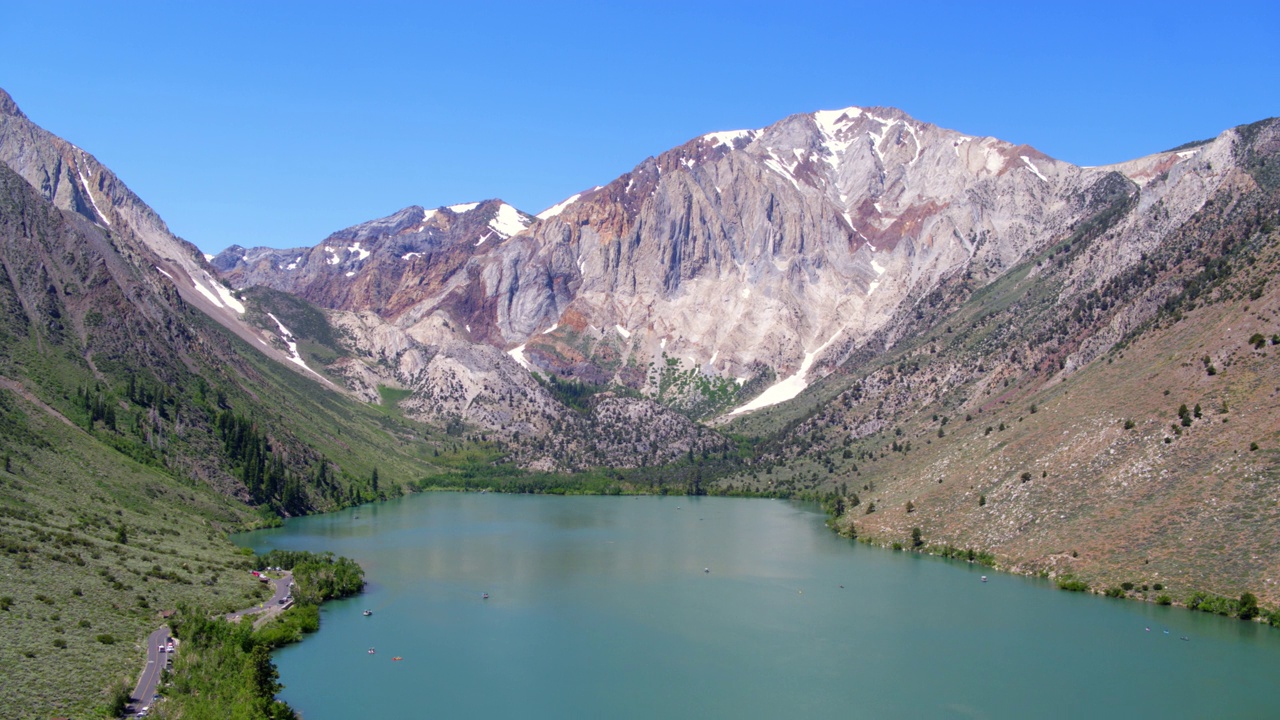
723 120 1280 603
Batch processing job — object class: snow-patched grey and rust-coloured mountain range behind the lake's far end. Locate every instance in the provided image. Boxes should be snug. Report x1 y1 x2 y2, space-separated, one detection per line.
222 108 1239 422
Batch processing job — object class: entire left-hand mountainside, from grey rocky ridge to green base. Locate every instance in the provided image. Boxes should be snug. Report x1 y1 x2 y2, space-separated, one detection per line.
0 83 512 717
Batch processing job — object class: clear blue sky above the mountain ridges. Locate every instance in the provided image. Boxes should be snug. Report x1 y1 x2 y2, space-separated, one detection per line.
0 0 1280 252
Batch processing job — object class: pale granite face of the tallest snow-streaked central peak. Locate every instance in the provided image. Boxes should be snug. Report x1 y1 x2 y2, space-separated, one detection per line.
485 108 1107 397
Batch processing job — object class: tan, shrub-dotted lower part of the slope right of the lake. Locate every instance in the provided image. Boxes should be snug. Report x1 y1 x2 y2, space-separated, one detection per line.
829 288 1280 605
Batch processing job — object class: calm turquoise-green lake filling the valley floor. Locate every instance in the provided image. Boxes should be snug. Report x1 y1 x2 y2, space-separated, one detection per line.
236 493 1280 720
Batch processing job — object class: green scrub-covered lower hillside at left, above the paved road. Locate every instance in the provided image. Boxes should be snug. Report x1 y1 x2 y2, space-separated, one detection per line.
0 391 261 717
